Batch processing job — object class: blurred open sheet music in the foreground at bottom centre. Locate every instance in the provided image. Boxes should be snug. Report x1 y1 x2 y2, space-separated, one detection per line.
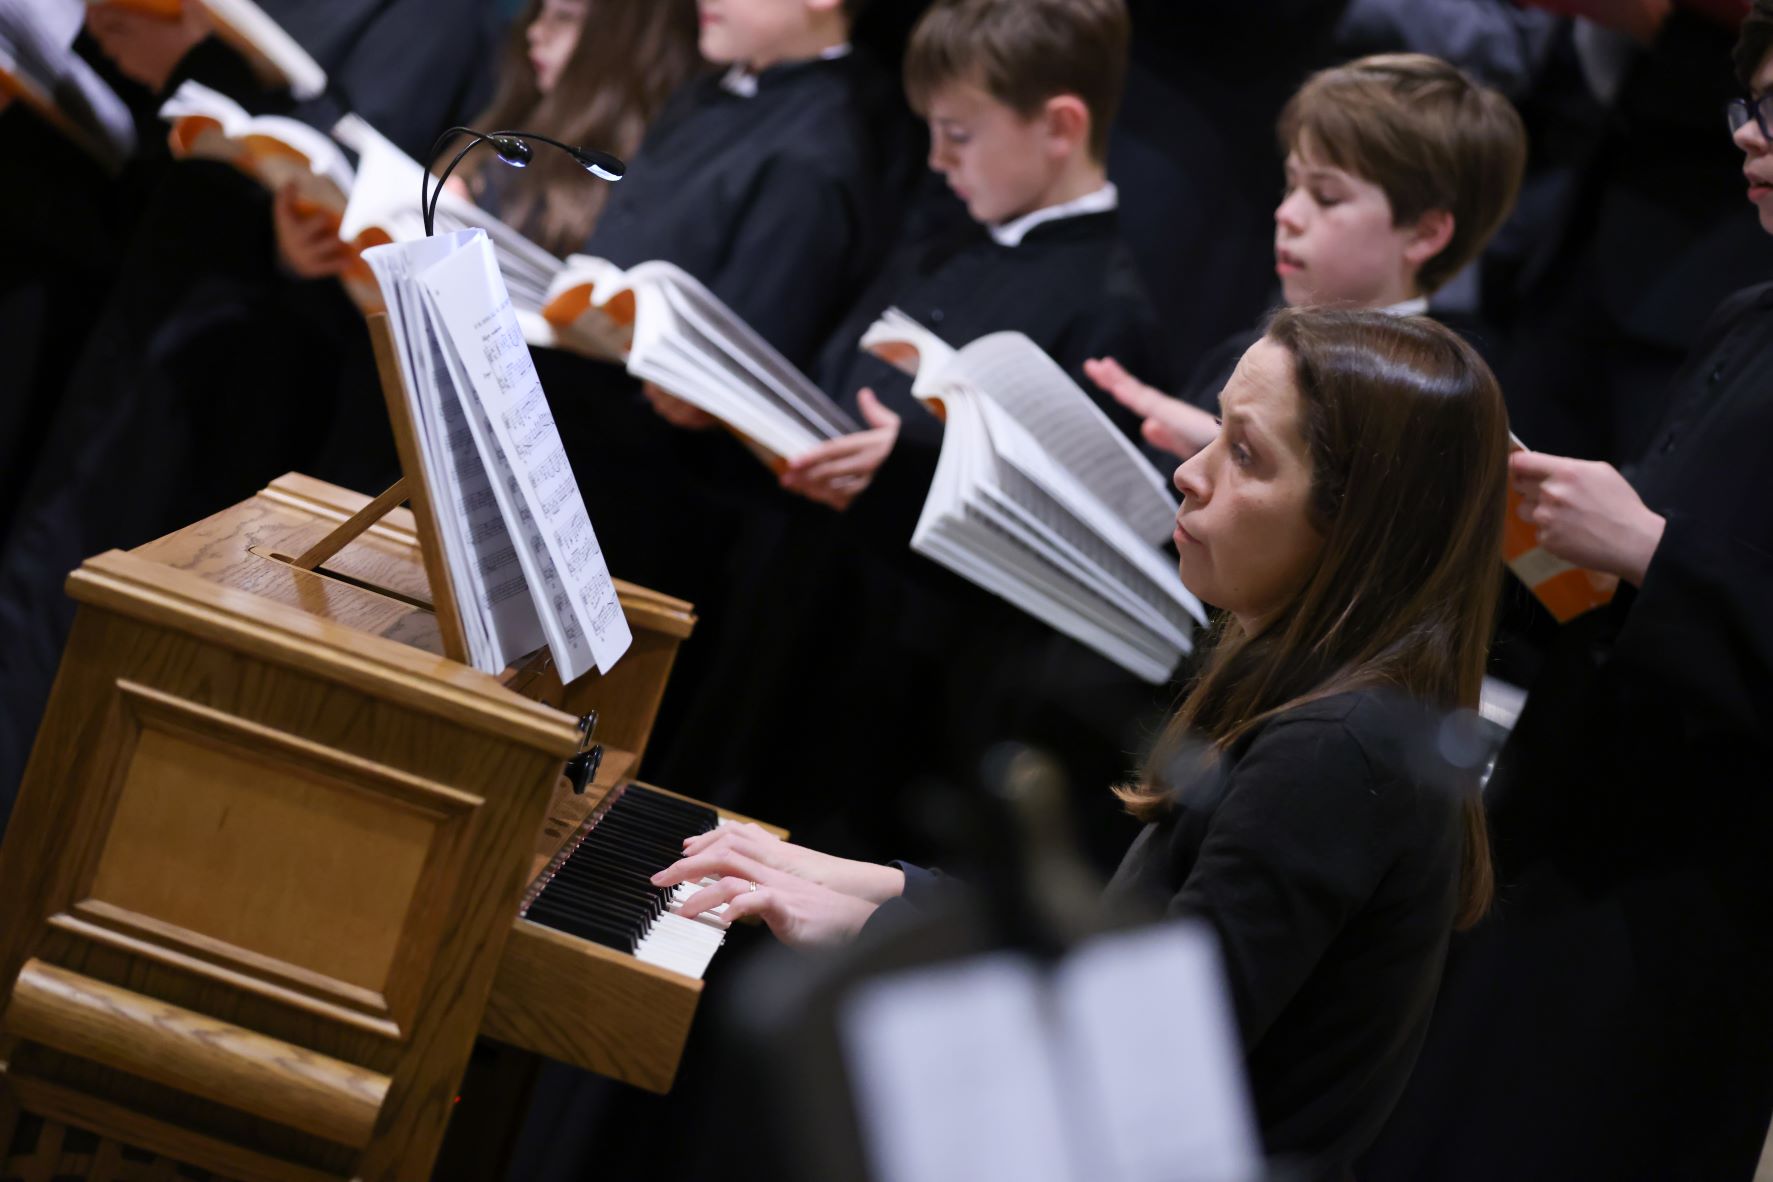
839 921 1268 1182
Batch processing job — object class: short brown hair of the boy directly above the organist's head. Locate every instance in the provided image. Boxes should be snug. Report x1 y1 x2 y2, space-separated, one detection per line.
1278 53 1527 292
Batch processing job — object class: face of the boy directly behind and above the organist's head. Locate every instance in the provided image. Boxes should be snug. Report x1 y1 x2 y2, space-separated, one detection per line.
1275 145 1418 307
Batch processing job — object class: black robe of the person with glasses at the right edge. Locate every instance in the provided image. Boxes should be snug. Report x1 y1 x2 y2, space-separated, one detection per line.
1360 285 1773 1182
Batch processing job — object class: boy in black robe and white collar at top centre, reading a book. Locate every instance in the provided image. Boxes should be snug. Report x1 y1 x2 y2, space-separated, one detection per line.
666 0 1165 868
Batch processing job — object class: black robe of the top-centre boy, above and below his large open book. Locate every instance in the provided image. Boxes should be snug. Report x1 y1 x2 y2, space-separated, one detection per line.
652 213 1165 867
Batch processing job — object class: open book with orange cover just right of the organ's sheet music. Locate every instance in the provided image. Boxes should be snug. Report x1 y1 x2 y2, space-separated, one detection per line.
532 255 860 459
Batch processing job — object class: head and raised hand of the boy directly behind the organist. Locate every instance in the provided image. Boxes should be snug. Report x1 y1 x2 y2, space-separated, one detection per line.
1089 53 1527 457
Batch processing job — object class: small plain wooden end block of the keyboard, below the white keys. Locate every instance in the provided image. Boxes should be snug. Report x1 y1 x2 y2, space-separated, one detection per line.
480 920 702 1092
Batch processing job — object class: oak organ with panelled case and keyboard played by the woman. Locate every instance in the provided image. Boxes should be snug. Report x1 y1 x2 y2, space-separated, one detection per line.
0 475 776 1182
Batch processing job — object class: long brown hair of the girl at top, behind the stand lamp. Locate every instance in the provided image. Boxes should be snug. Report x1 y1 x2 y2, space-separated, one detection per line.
459 0 700 255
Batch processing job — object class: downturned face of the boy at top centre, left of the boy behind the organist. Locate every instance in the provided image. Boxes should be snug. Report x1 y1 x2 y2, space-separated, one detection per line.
926 82 1062 225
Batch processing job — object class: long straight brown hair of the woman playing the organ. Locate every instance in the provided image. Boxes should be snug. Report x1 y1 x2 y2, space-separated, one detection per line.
1117 308 1509 927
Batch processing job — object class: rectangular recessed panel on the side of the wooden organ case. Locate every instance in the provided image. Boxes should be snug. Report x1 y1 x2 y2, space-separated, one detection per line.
76 682 480 1023
